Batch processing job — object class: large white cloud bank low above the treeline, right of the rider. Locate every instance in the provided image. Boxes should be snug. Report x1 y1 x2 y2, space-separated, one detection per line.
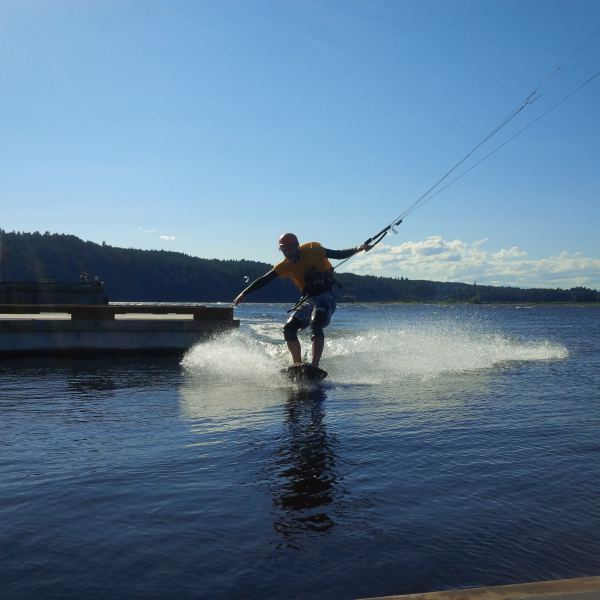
348 236 600 289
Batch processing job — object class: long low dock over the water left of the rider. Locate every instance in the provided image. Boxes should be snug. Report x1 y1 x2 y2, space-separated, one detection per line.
0 303 239 358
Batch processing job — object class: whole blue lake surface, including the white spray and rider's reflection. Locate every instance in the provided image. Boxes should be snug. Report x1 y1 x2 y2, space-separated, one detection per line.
0 305 600 600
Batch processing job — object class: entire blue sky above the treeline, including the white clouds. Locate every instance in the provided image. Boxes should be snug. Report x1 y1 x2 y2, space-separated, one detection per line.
0 0 600 289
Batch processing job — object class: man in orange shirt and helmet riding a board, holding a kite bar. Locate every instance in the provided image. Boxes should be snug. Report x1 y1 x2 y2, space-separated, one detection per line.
233 233 369 367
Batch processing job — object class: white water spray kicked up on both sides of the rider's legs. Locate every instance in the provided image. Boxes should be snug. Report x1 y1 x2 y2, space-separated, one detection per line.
182 322 568 387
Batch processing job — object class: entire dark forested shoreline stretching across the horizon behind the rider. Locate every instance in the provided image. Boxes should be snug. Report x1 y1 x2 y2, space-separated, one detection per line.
1 232 600 303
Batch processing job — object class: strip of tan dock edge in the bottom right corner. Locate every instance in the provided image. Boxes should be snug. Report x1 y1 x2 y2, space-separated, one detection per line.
364 577 600 600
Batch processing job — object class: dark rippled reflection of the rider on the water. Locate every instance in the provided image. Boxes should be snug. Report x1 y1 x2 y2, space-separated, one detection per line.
273 388 339 541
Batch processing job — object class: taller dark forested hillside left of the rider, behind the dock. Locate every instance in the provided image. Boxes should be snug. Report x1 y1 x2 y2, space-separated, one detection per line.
2 233 295 302
